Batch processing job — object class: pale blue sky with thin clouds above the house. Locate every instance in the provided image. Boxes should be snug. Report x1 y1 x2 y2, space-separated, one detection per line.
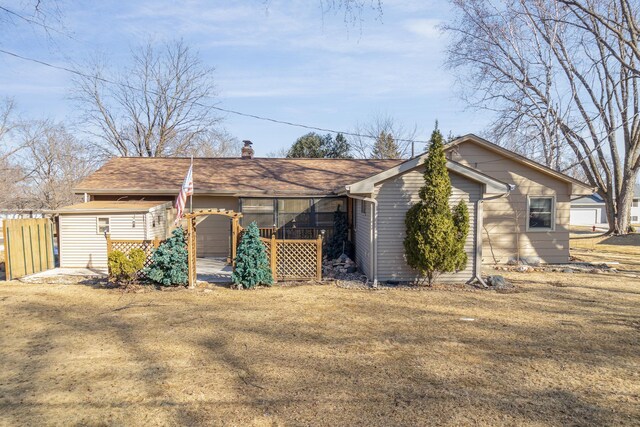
0 0 490 155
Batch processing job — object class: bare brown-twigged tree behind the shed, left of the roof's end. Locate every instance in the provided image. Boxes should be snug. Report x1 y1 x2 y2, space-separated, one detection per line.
20 120 97 209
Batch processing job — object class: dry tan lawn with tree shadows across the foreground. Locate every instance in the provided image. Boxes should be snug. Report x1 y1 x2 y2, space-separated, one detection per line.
0 273 640 426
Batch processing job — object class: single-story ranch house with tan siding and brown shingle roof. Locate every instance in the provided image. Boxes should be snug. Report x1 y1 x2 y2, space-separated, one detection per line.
60 135 593 282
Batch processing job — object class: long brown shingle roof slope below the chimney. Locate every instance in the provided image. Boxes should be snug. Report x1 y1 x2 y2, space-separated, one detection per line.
75 157 402 195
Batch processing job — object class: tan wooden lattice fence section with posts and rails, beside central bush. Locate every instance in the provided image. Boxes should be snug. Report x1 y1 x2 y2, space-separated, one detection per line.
260 234 322 281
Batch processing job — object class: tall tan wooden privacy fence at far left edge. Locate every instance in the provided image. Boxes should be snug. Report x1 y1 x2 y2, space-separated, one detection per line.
2 218 55 280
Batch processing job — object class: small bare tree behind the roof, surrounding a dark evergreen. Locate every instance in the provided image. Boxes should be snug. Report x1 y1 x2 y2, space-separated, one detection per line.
349 114 425 159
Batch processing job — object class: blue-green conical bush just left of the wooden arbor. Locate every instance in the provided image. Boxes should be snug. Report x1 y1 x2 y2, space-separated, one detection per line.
144 227 189 286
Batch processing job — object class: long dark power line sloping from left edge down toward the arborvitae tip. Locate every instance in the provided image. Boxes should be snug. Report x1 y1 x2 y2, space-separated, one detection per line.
0 49 429 144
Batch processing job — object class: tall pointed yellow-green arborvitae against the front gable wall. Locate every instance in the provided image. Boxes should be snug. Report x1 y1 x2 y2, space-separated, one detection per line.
404 129 469 285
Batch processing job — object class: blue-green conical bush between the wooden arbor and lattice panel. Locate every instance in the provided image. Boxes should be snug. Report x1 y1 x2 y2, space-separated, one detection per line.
231 221 273 289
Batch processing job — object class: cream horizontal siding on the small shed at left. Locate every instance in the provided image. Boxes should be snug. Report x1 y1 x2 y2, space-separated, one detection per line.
60 213 147 269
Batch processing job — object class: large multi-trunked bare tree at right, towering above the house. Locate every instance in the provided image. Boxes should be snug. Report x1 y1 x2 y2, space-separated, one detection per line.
444 0 640 234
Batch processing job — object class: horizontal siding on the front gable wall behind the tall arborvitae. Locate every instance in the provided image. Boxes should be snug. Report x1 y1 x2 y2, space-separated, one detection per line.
376 171 482 282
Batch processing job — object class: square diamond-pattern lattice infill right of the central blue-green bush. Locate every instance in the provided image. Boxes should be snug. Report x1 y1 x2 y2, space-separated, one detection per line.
276 240 317 279
